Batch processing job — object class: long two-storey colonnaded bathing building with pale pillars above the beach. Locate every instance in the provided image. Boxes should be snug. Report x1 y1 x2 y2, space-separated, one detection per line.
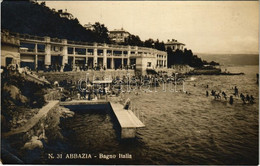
1 31 167 73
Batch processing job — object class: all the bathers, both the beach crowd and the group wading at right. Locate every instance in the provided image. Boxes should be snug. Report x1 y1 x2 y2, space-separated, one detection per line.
53 70 255 105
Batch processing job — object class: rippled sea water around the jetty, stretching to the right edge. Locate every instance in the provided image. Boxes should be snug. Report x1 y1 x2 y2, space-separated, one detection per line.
42 66 259 164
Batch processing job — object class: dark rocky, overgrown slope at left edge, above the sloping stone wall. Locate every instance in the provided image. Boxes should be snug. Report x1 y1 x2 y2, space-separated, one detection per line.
1 70 48 131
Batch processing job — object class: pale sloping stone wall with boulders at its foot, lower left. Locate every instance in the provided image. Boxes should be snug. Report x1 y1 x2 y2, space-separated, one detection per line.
1 106 74 164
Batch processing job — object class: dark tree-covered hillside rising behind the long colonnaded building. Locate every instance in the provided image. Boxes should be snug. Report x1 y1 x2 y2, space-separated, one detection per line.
2 1 214 67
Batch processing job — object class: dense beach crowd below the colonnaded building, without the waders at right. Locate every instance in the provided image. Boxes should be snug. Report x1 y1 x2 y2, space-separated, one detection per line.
54 73 187 100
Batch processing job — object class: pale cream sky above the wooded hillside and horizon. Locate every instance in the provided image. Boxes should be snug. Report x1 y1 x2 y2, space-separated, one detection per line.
46 1 259 54
